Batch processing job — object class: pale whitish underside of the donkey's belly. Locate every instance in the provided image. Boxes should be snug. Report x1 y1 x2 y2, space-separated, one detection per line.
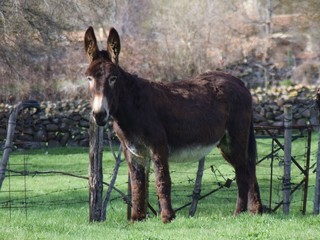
169 143 218 162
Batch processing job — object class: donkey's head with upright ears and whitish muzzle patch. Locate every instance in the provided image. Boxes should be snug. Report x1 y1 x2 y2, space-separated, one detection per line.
84 27 120 126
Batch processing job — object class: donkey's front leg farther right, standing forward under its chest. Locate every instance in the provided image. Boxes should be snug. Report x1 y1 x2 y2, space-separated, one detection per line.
152 146 175 223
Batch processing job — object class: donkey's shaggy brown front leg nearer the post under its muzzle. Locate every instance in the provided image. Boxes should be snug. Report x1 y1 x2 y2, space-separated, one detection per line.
129 162 149 222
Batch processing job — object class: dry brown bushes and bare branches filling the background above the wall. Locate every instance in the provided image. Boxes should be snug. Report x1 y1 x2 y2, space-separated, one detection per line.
0 0 320 102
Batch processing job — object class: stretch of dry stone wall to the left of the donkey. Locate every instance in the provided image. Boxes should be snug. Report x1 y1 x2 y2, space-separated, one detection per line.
0 100 90 148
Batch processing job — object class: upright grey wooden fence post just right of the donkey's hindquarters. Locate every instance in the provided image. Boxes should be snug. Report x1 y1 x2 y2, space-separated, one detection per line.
283 105 292 214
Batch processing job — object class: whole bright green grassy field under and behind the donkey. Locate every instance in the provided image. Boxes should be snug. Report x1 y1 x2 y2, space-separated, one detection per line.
0 133 320 240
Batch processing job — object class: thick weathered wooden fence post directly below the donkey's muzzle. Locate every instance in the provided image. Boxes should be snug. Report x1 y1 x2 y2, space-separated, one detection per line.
89 115 104 222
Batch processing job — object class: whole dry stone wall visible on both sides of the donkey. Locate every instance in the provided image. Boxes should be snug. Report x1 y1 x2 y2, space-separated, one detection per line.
0 85 317 148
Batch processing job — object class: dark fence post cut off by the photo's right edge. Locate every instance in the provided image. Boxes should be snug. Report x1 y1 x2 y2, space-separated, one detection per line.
313 88 320 214
